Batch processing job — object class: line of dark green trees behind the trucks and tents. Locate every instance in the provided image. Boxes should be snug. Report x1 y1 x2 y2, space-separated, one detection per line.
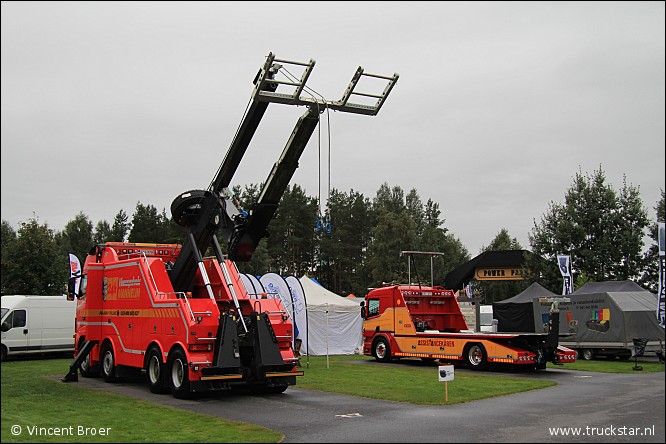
1 168 664 303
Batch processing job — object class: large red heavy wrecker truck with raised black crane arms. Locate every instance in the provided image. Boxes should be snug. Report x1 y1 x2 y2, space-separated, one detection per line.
63 53 398 397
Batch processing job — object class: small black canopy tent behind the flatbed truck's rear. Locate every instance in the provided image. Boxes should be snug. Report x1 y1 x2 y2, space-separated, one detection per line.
493 282 557 333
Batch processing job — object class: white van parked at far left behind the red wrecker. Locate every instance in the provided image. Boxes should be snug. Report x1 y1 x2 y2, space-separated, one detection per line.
1 295 76 361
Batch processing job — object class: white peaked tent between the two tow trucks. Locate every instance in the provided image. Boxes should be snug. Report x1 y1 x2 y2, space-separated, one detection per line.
298 276 363 356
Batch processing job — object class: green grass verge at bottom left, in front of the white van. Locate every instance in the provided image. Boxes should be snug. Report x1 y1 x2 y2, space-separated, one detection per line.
1 359 283 443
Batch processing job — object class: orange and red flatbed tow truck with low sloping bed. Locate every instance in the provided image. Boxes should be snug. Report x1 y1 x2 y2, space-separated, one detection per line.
361 285 576 370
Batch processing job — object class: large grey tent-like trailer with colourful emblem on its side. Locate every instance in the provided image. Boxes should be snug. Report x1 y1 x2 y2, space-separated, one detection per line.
534 281 664 348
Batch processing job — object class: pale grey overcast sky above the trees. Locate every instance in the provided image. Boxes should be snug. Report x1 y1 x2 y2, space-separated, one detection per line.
1 1 665 256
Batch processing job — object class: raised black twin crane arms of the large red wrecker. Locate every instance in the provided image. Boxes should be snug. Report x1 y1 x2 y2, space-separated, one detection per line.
169 53 398 291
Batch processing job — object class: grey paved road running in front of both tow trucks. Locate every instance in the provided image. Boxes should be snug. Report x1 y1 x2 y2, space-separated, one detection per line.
66 361 666 443
